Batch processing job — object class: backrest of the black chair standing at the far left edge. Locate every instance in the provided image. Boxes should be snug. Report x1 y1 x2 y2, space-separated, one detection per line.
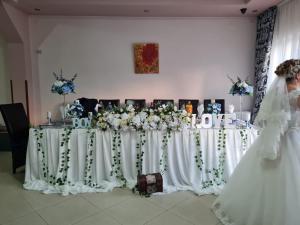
0 103 29 144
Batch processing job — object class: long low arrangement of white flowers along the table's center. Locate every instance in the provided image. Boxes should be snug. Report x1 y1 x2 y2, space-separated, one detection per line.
93 105 191 131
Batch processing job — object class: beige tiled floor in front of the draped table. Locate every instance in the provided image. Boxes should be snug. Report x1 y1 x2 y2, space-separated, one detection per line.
0 152 220 225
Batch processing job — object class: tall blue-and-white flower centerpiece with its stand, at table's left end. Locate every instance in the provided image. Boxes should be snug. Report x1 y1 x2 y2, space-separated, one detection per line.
51 70 77 123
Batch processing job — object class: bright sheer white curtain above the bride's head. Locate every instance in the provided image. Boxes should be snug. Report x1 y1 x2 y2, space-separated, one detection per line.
267 0 300 88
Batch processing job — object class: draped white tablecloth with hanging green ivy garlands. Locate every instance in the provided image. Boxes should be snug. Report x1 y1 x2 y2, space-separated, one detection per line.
24 128 257 195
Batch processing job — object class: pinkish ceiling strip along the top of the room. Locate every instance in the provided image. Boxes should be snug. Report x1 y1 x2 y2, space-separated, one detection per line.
5 0 282 17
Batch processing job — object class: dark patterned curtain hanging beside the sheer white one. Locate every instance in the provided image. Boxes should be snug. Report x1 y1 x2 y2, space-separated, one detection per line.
252 6 277 121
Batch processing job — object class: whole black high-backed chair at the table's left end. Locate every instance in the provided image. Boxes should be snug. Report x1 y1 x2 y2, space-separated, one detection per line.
0 103 29 173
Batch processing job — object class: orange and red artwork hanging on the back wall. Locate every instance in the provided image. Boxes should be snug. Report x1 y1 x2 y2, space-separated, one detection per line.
134 43 159 74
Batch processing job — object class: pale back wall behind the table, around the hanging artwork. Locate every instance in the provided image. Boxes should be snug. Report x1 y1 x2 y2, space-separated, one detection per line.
30 16 256 123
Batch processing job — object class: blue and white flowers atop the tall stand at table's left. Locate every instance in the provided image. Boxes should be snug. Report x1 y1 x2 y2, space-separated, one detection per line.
51 70 77 95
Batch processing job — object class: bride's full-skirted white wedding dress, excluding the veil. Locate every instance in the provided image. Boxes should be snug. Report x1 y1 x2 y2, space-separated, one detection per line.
212 90 300 225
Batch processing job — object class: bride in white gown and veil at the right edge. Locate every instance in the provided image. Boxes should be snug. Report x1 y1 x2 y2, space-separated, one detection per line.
212 59 300 225
